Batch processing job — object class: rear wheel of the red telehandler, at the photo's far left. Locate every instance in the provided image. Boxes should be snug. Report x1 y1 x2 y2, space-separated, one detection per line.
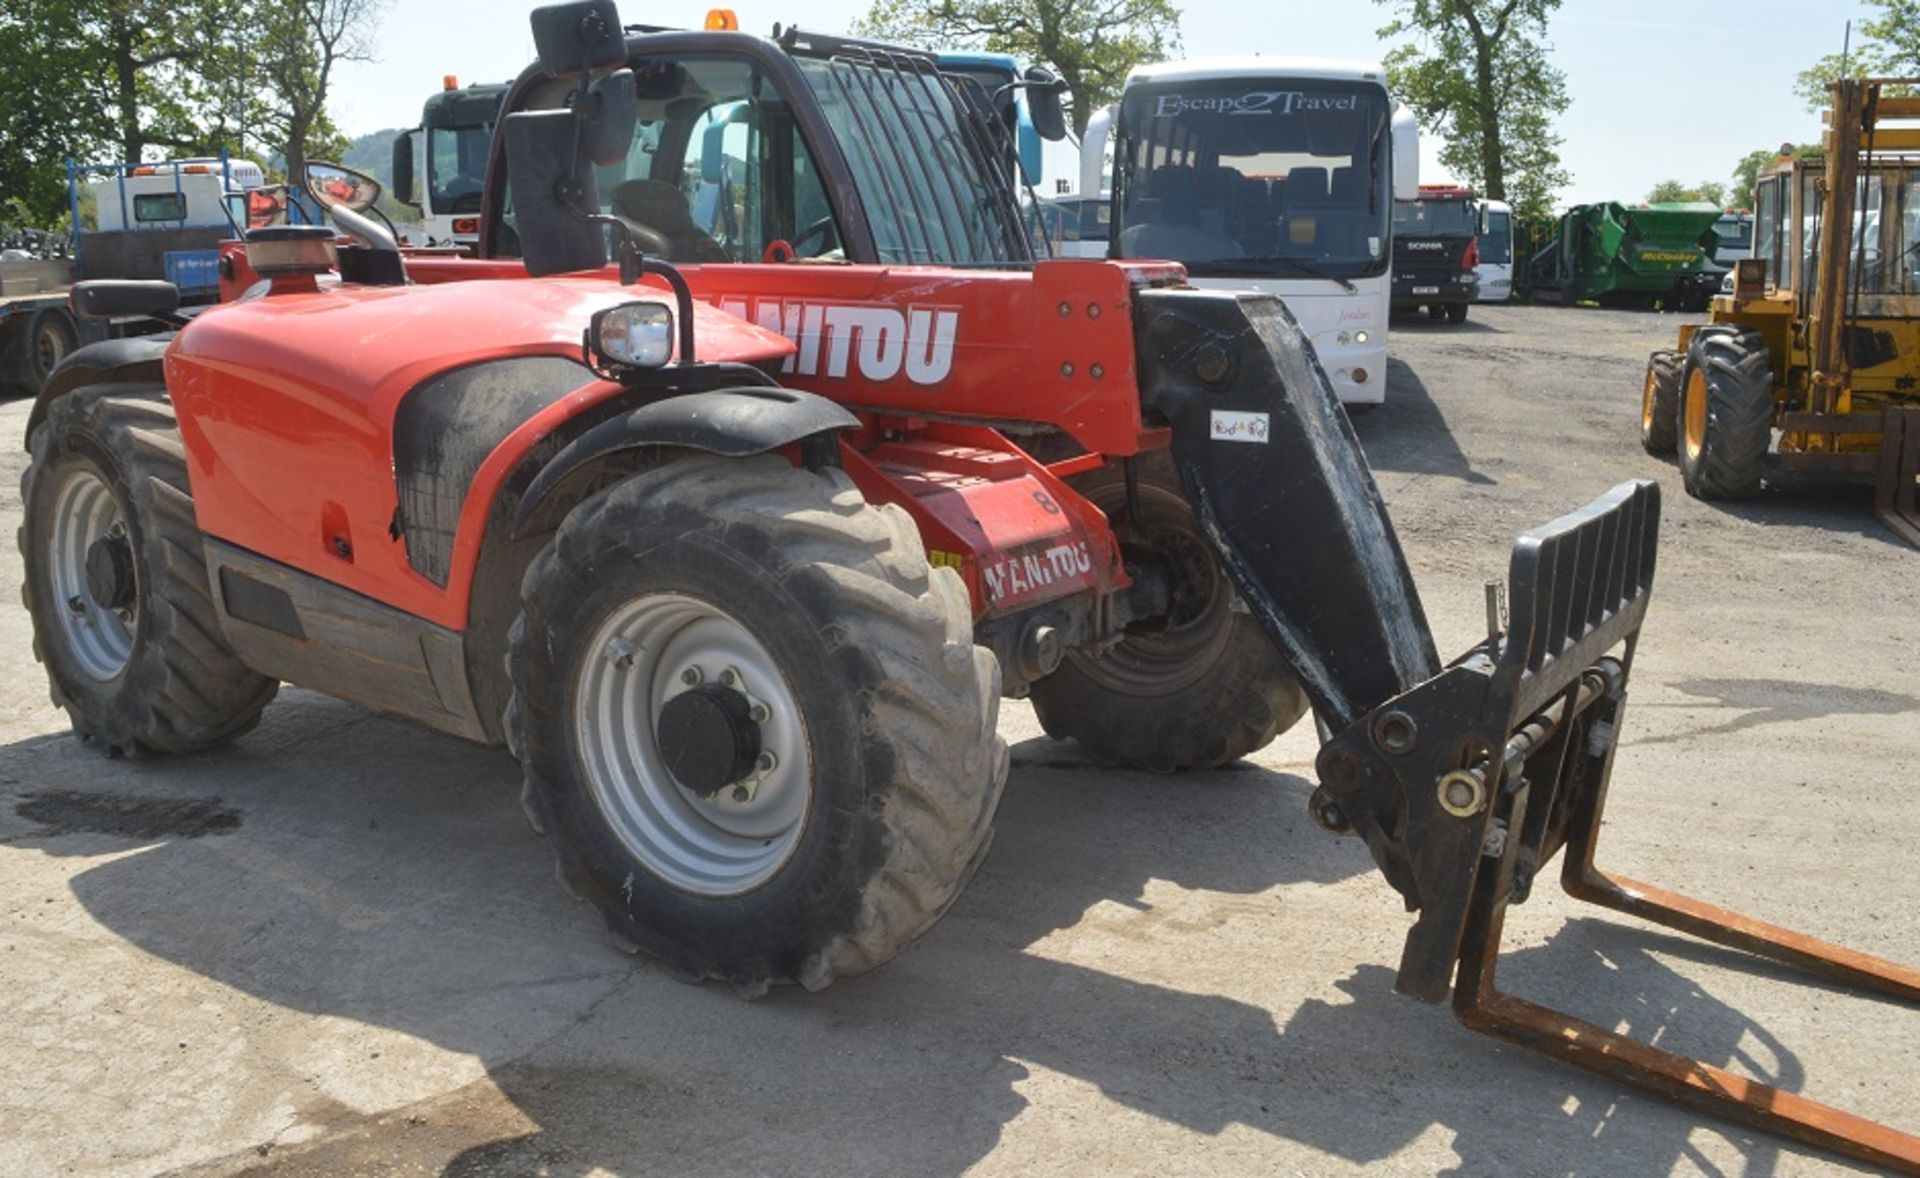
19 384 280 756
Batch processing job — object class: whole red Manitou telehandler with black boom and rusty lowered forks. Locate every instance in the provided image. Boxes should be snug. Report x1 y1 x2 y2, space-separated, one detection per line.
21 0 1920 1168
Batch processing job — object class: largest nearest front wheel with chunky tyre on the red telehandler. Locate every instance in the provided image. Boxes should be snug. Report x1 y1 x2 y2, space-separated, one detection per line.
505 457 1008 998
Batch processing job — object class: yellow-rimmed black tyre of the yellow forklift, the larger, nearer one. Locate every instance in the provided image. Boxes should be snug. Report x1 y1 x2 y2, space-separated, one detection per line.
1678 328 1774 499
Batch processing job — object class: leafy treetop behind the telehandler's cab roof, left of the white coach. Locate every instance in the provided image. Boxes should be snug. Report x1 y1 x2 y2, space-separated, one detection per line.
854 0 1181 134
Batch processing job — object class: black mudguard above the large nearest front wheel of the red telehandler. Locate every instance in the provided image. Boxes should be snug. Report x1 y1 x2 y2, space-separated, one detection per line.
513 386 860 537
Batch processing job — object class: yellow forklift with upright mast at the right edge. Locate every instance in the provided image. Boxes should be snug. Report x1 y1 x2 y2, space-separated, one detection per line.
1640 79 1920 545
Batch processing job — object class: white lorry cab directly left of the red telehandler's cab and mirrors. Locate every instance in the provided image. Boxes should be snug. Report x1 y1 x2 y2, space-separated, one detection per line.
394 73 507 247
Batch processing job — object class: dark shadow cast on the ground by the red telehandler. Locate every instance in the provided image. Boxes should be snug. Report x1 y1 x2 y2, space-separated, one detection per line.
0 693 1858 1174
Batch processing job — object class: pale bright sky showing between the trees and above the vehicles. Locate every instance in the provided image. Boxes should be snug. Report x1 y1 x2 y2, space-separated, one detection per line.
330 0 1872 203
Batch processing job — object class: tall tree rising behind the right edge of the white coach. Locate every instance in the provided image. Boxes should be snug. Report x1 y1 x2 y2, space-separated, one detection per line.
1375 0 1571 217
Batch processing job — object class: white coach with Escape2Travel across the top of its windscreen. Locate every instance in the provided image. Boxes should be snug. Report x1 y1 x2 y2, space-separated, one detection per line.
1079 56 1419 409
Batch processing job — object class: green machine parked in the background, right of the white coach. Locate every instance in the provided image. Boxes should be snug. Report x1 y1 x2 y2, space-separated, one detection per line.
1528 201 1720 311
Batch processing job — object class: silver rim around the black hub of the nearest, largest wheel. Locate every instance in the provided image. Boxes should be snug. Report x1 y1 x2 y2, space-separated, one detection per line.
574 593 812 896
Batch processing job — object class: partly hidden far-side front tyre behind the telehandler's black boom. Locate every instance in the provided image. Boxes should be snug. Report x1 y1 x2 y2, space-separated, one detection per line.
1033 455 1308 773
